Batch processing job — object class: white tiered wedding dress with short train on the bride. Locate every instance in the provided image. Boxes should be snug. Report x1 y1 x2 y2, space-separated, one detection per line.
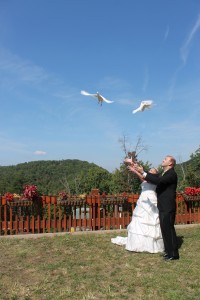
111 181 164 253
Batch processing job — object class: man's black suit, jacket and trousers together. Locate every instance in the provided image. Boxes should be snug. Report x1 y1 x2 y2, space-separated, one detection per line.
145 168 179 257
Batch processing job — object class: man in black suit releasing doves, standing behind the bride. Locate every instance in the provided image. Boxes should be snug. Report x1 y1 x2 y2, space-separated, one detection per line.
128 155 179 261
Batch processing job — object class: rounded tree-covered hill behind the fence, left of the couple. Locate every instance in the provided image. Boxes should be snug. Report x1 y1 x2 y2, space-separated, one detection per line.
0 159 112 195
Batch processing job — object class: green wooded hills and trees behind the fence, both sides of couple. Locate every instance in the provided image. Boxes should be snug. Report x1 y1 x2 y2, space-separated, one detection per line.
0 148 200 195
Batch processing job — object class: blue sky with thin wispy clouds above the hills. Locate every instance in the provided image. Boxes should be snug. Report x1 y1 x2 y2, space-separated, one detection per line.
0 0 200 171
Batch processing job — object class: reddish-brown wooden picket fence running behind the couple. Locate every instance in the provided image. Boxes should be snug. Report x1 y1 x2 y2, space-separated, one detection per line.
0 189 200 235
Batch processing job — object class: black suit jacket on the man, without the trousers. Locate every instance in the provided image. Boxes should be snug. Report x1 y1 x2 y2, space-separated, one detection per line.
145 168 178 212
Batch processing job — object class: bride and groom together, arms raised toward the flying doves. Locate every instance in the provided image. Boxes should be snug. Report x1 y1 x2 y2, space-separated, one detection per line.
111 155 179 261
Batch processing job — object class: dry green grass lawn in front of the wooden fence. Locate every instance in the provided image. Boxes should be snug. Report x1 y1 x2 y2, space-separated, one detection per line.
0 226 200 300
